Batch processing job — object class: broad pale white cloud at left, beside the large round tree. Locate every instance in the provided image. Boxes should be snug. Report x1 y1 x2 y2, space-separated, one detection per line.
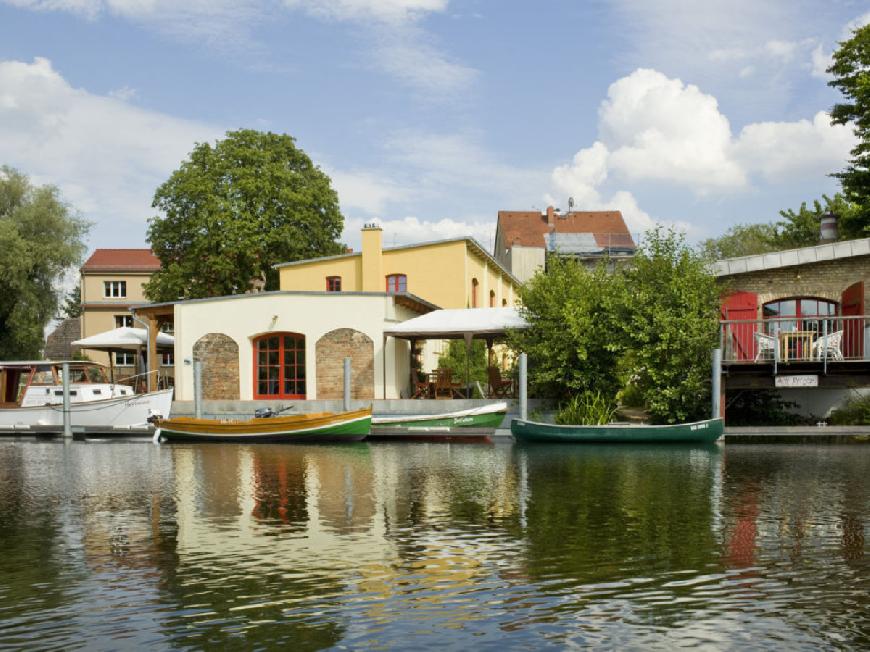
0 58 220 238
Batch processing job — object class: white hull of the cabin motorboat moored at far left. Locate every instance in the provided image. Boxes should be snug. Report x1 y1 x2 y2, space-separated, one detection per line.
0 389 173 432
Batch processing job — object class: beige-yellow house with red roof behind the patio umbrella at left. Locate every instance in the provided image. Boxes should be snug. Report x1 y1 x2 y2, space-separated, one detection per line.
81 249 165 375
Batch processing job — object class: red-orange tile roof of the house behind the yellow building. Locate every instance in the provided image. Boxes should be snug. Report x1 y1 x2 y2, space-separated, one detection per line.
497 211 635 247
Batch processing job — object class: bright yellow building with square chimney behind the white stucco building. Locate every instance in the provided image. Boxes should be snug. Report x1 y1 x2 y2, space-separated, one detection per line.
276 224 519 308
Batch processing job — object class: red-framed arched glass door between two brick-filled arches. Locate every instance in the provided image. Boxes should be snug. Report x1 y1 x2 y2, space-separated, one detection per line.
254 333 305 399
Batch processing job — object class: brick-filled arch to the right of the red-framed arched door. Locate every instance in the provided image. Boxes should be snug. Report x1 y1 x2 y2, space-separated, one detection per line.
316 328 375 400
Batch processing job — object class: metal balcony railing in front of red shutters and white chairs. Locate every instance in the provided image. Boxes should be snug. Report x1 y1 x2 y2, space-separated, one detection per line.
719 315 870 365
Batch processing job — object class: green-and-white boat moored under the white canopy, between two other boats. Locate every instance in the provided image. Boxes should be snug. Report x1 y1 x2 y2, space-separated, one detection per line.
371 403 507 439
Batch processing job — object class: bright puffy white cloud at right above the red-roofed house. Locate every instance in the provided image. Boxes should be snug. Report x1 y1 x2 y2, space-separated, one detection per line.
547 69 855 230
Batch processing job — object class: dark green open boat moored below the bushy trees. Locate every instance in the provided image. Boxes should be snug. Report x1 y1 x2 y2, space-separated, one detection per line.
511 419 723 444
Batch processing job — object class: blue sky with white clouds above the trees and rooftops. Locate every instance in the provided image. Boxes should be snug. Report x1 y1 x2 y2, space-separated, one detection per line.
0 0 870 255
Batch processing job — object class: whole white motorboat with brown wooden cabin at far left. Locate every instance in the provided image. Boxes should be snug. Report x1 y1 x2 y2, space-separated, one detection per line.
0 360 172 429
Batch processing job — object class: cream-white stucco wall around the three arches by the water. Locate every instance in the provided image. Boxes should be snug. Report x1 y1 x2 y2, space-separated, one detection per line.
175 292 419 401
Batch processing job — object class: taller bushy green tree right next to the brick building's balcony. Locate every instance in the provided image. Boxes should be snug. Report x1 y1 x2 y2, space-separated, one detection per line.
617 228 719 423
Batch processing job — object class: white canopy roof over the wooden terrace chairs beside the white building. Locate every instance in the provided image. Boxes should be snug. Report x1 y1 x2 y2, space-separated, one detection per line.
384 308 529 339
